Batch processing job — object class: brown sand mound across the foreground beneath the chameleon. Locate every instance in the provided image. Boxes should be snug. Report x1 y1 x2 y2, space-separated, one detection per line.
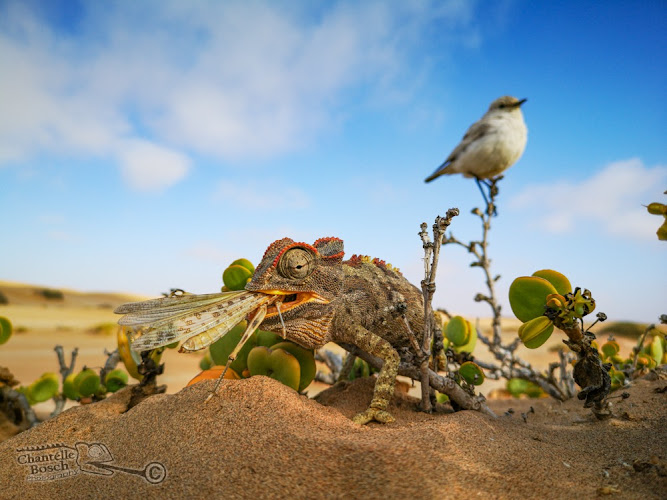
0 377 667 499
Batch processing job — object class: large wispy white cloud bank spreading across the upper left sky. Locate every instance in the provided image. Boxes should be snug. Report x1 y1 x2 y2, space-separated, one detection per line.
0 0 474 183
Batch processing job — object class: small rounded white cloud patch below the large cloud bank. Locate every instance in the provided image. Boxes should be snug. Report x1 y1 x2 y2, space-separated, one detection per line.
118 140 190 191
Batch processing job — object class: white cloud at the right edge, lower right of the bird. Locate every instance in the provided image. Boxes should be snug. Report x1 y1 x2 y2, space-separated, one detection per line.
510 158 667 239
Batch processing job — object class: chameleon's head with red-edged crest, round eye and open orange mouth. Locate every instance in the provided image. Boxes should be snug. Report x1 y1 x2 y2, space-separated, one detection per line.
245 238 344 336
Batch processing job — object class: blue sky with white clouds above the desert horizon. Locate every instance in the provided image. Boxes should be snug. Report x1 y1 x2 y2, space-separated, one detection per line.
0 0 667 322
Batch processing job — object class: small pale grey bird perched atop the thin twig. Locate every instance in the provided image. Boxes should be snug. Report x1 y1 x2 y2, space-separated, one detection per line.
425 96 528 184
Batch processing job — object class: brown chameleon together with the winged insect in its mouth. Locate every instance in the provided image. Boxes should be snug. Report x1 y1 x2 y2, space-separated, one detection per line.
116 237 424 424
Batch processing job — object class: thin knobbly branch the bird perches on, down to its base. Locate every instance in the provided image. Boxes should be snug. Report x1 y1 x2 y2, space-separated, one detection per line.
443 176 575 401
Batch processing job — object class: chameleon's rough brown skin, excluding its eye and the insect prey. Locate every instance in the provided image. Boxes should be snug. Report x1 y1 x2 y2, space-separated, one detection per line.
246 238 424 424
